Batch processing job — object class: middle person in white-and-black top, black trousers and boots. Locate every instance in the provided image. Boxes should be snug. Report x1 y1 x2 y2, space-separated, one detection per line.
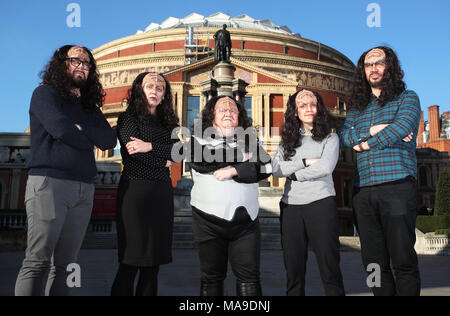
185 96 271 296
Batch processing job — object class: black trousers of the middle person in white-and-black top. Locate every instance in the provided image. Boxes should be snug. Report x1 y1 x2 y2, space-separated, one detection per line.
192 206 261 283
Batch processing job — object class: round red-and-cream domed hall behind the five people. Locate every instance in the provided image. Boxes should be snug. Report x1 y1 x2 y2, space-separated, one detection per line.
93 12 354 198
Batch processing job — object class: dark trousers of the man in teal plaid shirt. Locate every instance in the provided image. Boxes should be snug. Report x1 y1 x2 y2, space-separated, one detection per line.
353 177 420 296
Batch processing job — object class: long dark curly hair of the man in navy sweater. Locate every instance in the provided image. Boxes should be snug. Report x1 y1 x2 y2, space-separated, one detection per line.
39 45 105 111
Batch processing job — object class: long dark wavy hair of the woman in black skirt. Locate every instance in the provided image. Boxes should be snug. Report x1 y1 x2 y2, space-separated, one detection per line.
127 72 179 131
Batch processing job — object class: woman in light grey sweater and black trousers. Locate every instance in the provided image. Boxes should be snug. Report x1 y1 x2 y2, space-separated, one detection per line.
272 90 345 296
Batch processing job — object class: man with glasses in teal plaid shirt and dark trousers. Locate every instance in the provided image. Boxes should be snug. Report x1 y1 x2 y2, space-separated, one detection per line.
339 46 421 295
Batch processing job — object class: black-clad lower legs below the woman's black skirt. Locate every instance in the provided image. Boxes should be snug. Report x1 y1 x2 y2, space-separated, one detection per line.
111 263 159 296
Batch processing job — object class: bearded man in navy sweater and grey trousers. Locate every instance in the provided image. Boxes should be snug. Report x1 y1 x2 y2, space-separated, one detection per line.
15 45 116 296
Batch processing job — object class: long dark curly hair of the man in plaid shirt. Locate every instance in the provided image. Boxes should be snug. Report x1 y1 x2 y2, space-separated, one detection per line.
349 46 406 111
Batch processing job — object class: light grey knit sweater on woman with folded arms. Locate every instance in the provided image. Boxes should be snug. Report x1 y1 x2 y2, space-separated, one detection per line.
272 133 339 205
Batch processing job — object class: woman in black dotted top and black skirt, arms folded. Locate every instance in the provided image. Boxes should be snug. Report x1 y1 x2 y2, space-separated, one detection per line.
111 72 178 296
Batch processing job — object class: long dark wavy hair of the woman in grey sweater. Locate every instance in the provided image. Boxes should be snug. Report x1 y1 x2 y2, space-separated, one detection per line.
281 90 335 160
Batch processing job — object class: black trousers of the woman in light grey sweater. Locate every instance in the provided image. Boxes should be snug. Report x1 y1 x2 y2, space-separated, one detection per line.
280 196 345 296
